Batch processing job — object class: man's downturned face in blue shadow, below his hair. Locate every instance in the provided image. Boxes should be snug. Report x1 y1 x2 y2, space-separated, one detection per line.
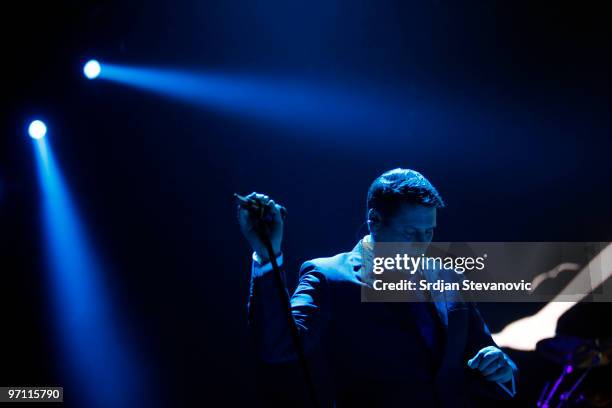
372 204 436 244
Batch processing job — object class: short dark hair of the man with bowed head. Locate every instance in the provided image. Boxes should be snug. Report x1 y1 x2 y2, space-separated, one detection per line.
368 168 445 217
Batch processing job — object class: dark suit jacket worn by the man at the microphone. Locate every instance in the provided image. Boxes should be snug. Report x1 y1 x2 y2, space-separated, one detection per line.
249 241 516 408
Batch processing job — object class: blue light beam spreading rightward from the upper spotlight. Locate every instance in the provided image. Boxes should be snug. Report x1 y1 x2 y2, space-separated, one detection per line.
100 63 418 136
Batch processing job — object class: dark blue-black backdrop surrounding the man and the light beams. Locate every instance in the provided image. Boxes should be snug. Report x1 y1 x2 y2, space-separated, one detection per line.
0 0 612 405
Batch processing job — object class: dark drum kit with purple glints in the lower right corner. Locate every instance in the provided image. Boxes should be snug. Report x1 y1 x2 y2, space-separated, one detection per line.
536 336 612 408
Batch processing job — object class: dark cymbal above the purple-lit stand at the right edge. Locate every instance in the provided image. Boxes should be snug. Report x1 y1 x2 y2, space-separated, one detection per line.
536 336 612 368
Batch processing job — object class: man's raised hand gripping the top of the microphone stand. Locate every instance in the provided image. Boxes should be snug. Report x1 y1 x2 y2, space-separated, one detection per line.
238 193 283 263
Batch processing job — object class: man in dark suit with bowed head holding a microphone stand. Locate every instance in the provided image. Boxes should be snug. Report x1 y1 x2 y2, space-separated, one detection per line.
238 169 517 408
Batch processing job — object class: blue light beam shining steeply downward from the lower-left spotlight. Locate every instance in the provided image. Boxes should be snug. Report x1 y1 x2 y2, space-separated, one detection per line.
34 138 150 408
